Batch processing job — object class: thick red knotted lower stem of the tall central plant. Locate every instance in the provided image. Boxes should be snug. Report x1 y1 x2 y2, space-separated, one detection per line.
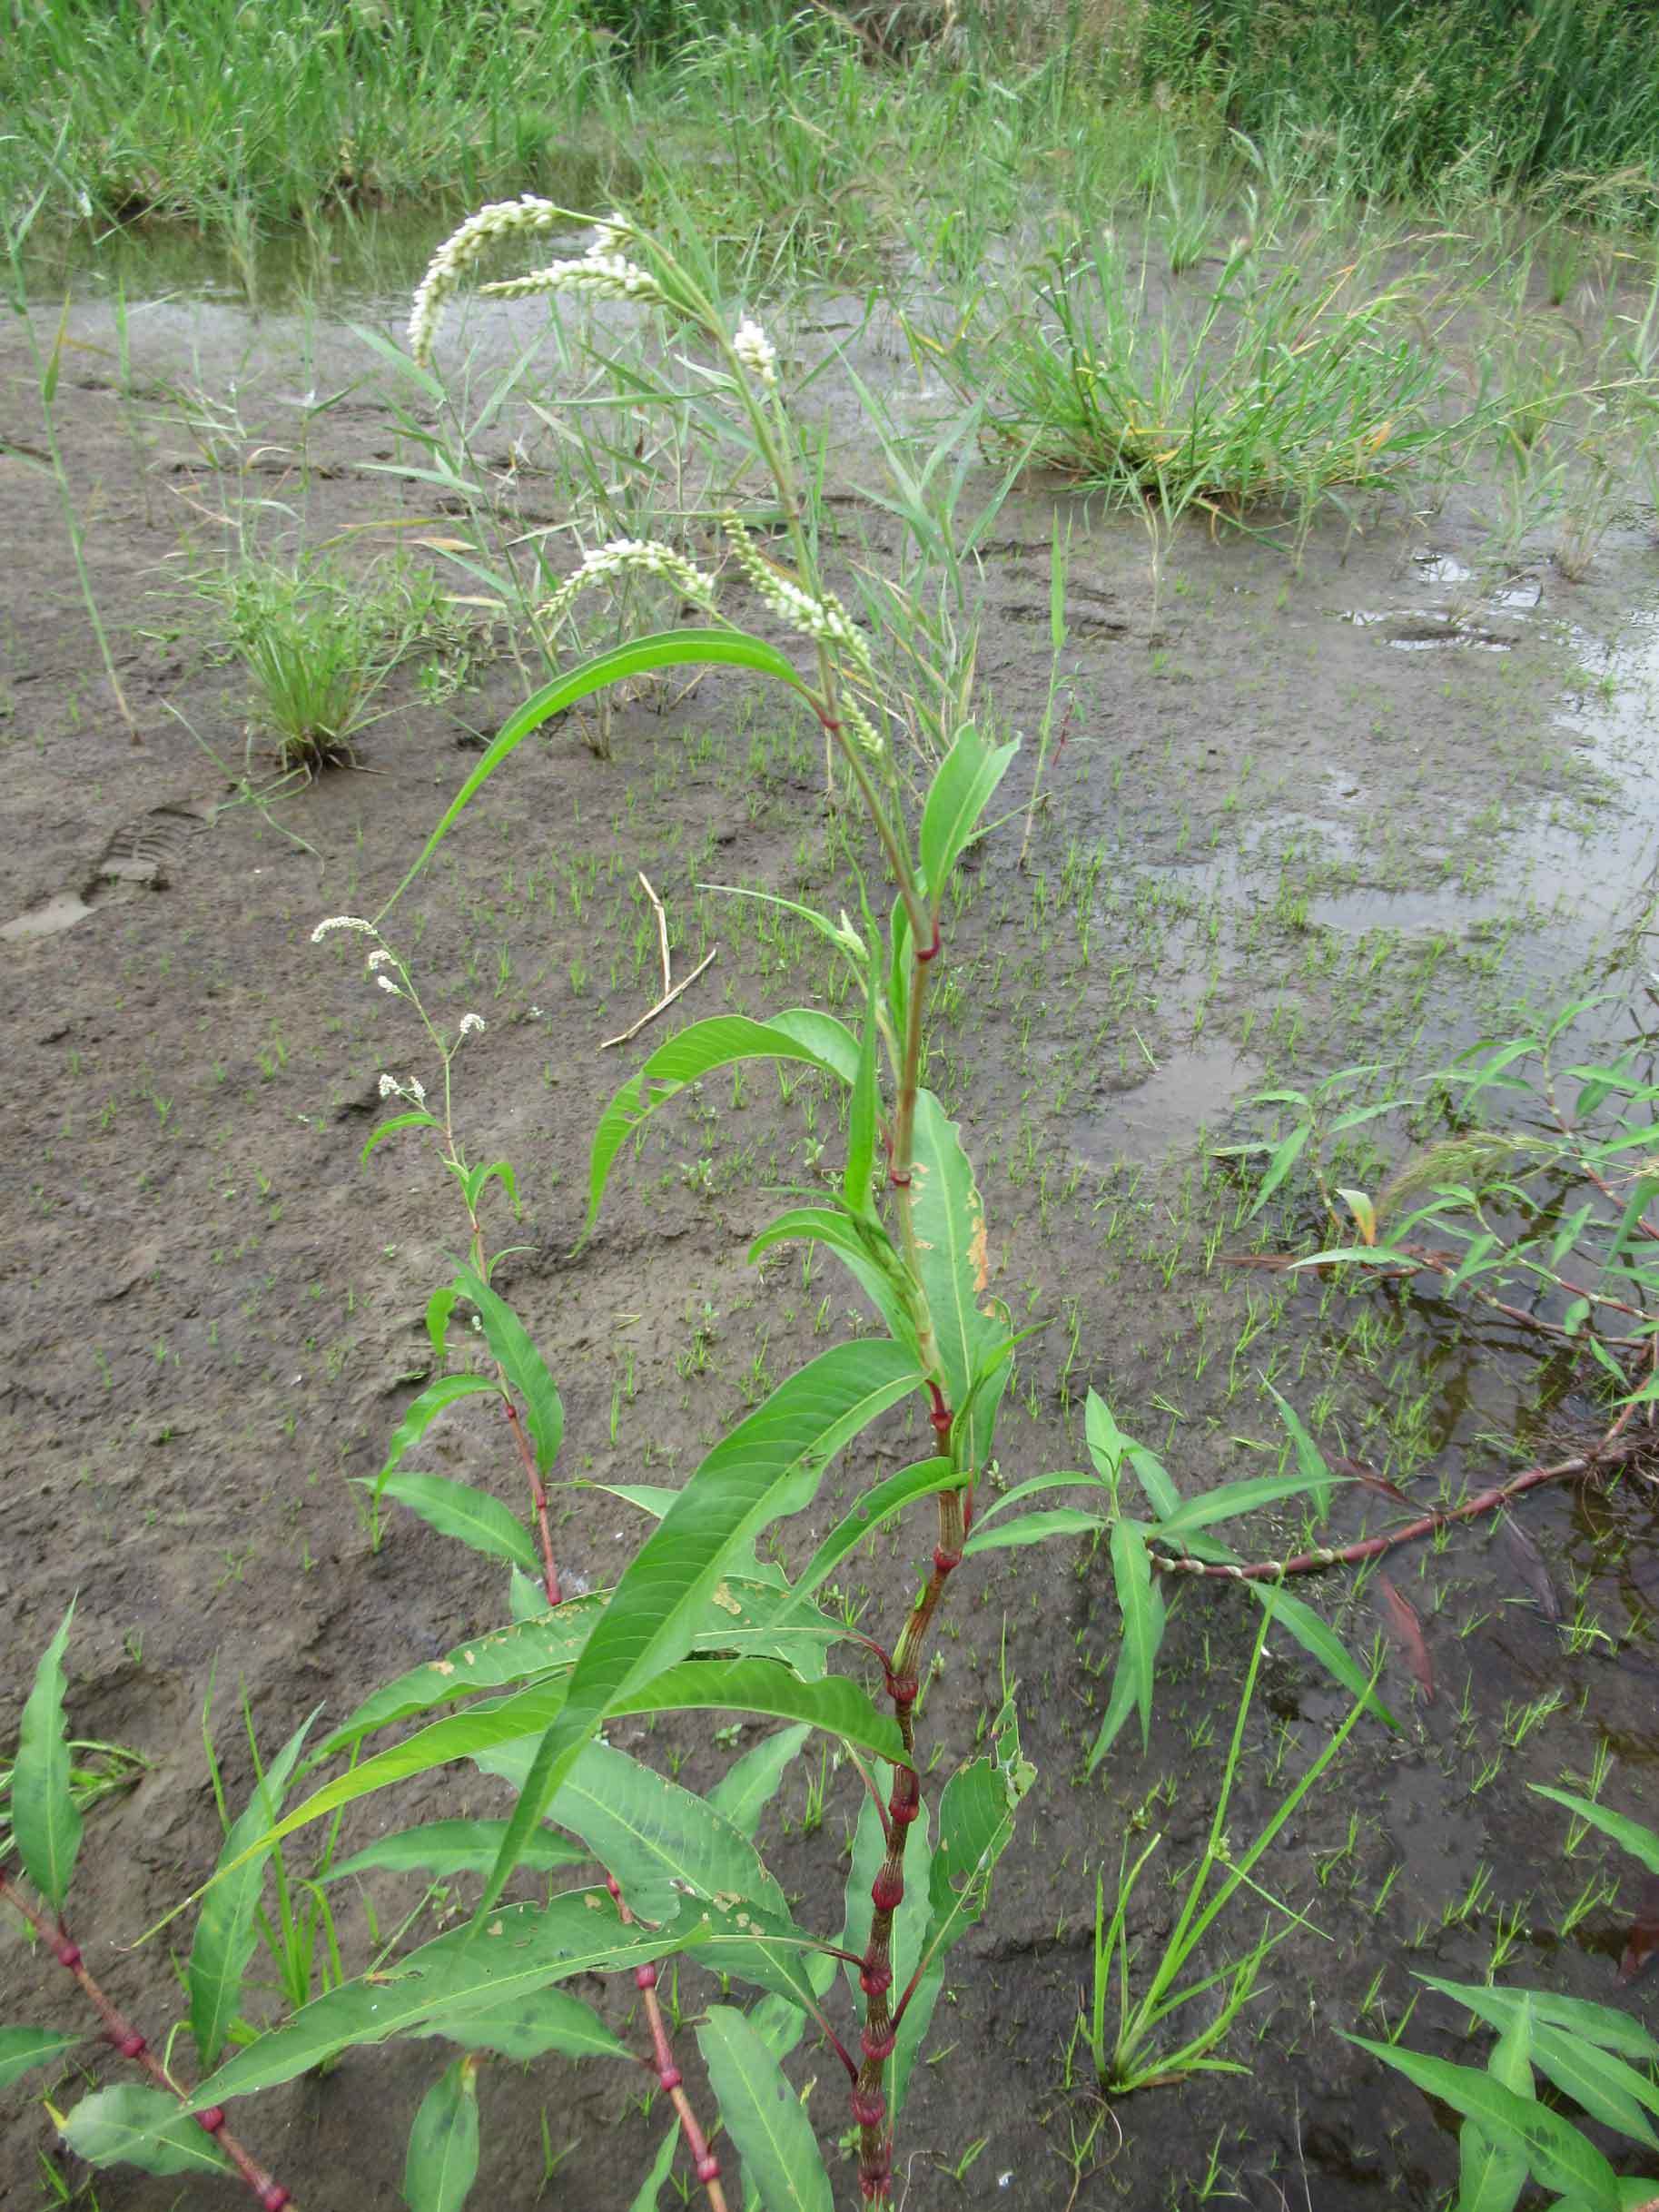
852 1468 973 2203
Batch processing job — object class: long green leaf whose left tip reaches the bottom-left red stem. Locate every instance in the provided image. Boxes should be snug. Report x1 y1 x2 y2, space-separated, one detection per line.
190 1889 695 2106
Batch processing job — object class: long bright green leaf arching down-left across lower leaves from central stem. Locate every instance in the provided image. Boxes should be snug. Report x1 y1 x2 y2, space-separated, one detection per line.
480 1340 920 1909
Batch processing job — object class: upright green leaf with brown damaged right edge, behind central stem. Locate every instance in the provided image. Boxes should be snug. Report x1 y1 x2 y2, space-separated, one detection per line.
912 1091 1009 1469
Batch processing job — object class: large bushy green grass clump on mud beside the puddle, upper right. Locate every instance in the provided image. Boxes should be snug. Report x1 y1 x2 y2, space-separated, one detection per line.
944 239 1447 535
